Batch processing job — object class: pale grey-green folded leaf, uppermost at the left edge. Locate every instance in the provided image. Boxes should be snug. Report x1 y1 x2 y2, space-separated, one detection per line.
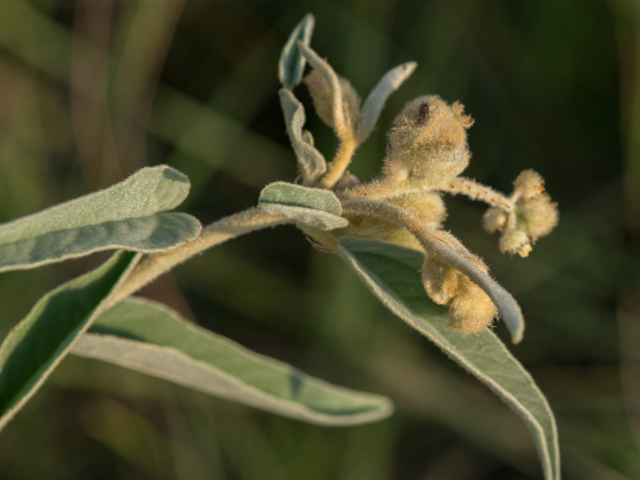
0 165 202 272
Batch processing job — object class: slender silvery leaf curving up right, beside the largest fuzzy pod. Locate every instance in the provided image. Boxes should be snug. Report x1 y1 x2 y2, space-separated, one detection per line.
357 62 418 143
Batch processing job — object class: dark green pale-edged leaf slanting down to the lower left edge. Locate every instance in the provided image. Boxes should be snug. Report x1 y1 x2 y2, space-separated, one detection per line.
0 251 142 429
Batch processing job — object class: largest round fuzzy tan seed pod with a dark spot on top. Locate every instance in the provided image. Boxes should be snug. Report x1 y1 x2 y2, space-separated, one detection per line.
386 95 473 185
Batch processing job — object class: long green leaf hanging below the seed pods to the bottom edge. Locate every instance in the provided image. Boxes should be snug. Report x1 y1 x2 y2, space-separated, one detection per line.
339 239 560 480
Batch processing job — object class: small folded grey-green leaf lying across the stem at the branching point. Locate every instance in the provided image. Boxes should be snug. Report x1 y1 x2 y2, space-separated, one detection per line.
258 182 349 230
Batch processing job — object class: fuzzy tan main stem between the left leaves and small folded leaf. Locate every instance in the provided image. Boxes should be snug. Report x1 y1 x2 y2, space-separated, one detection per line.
111 207 291 305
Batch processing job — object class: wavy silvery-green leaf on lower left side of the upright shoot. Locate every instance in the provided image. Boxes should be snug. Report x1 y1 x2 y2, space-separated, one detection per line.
280 88 327 182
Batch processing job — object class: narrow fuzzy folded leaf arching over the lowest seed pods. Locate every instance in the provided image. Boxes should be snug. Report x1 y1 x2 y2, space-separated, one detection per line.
342 200 524 343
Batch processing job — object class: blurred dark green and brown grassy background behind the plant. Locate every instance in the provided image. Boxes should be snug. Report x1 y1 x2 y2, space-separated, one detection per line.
0 0 640 480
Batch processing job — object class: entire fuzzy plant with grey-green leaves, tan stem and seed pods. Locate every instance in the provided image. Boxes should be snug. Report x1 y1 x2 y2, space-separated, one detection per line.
0 15 560 479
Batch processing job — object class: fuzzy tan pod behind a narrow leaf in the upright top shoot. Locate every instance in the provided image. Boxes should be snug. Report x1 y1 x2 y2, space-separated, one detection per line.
304 70 360 128
